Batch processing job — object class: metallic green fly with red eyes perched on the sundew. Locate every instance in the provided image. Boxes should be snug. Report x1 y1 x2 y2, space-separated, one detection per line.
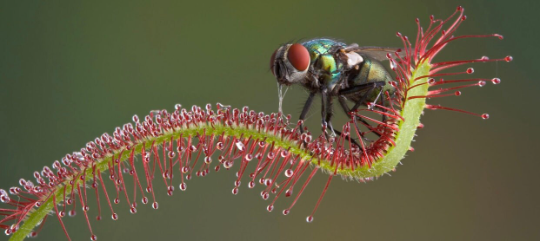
270 39 401 142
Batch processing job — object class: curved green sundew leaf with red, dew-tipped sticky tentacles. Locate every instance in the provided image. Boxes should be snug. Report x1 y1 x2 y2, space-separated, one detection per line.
0 7 512 240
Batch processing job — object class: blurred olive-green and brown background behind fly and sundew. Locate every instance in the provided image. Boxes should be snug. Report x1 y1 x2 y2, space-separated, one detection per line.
0 0 540 240
